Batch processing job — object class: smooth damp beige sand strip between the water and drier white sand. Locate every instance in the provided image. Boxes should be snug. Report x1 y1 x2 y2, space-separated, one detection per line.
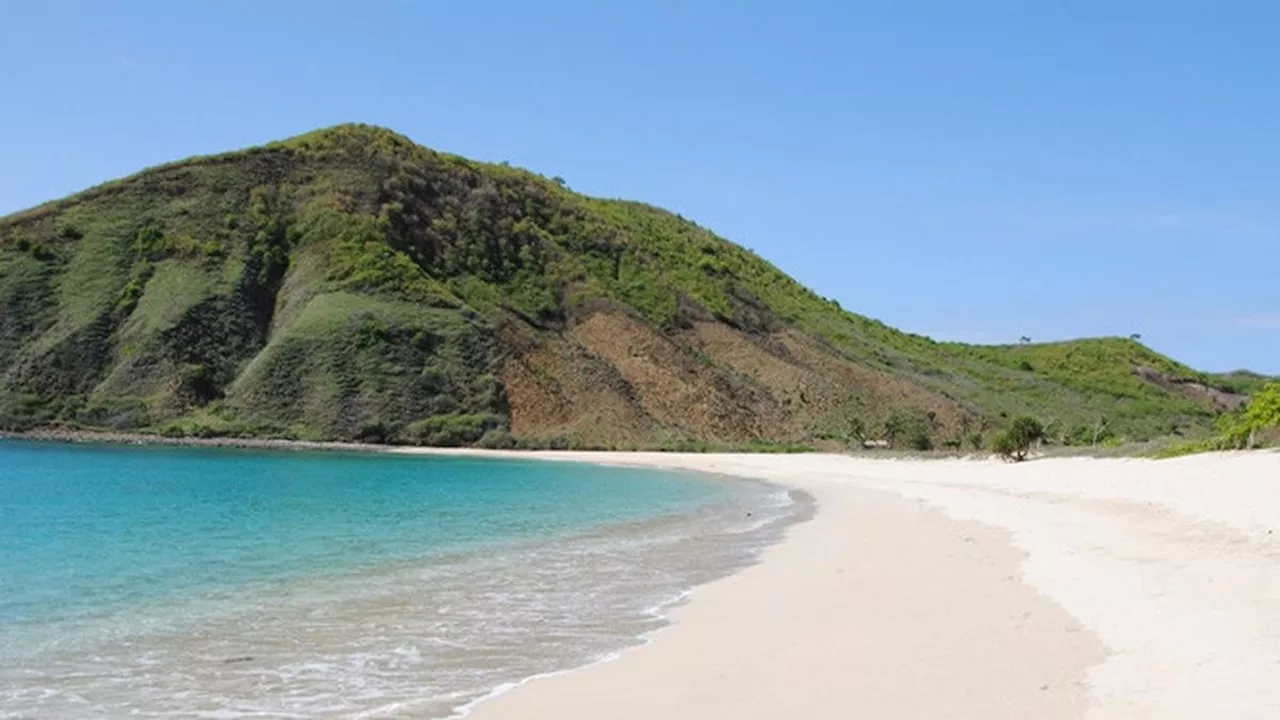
412 448 1105 720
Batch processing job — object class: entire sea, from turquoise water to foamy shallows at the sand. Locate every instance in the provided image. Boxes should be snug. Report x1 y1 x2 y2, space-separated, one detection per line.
0 441 805 719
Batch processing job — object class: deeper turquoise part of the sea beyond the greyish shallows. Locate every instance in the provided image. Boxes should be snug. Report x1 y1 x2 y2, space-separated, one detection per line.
0 443 722 623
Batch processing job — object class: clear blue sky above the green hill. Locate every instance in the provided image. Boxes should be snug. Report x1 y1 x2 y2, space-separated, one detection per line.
0 0 1280 373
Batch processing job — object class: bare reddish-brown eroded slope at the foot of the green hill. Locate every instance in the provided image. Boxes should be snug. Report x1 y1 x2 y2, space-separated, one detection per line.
500 295 966 446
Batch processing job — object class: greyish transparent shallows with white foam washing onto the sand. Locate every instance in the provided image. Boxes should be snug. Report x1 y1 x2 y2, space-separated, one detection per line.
0 476 804 720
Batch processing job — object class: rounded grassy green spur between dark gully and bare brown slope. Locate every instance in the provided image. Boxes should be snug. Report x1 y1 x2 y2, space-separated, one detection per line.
227 292 500 442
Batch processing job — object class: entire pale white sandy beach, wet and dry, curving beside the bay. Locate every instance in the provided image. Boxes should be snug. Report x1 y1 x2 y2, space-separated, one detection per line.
391 454 1280 720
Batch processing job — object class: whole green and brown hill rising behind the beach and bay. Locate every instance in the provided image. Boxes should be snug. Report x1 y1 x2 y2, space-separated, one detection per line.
0 126 1257 446
